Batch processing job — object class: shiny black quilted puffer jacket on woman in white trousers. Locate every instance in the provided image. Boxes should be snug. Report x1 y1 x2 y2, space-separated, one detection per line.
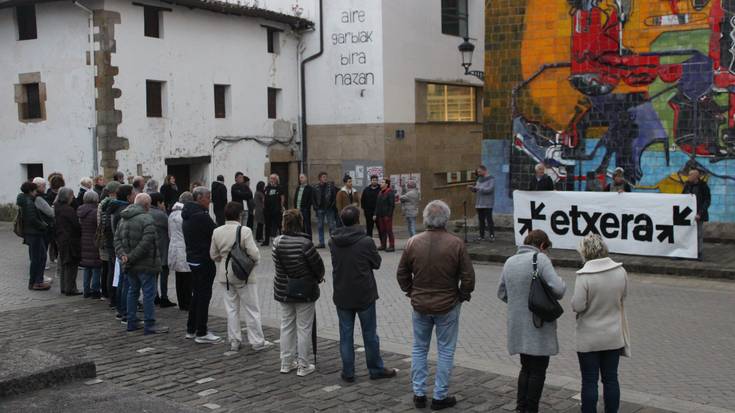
273 232 324 303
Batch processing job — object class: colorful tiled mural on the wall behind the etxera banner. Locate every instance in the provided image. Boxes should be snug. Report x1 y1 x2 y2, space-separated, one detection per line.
483 0 735 222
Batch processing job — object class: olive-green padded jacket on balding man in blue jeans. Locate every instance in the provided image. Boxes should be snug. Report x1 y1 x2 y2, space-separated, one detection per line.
115 205 161 274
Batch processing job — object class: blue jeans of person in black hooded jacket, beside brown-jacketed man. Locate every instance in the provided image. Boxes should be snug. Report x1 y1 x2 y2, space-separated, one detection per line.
337 303 384 377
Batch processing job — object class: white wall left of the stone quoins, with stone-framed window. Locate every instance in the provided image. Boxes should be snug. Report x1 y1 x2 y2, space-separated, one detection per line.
0 2 93 203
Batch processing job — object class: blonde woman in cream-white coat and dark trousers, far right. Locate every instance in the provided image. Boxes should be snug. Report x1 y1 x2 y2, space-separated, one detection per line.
572 234 630 413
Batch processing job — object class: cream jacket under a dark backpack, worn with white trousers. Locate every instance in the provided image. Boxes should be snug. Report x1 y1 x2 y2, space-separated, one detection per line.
209 221 260 286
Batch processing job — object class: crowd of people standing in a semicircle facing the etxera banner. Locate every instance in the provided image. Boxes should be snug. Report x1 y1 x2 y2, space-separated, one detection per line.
16 167 630 412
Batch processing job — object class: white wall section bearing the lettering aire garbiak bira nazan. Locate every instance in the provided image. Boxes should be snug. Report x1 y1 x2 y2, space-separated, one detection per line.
305 0 389 125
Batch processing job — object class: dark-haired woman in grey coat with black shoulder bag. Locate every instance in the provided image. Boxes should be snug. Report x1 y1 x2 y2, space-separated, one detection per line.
498 229 566 413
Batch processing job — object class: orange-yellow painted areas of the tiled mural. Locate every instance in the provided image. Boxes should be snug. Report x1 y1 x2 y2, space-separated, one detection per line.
521 0 712 130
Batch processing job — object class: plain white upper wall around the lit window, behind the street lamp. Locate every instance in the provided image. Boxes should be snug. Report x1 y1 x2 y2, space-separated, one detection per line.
383 0 485 123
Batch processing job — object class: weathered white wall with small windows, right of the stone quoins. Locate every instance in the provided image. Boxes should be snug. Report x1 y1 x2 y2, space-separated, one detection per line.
106 0 298 187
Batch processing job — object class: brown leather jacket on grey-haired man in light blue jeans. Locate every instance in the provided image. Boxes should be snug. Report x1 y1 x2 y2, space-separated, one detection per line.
397 229 475 314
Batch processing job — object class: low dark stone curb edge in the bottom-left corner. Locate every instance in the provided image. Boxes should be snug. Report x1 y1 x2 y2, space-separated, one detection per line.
0 361 97 397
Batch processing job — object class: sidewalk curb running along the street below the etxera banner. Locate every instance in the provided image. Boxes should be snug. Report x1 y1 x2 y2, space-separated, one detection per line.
470 252 735 280
